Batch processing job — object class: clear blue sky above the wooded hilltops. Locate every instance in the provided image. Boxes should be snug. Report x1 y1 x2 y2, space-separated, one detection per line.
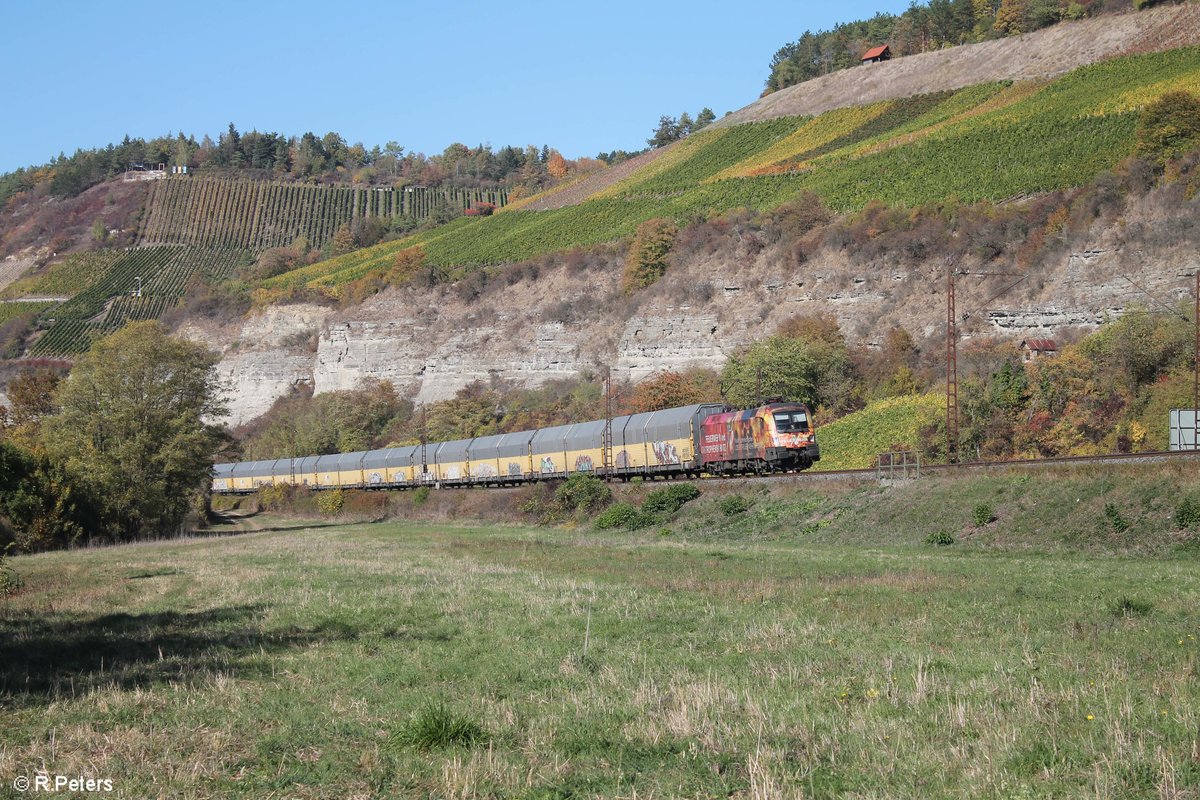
0 0 908 173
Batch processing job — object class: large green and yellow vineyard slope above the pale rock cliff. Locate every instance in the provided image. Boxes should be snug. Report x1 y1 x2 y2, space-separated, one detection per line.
266 47 1200 287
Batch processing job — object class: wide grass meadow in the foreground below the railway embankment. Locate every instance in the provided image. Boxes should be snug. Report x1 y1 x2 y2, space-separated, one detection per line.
0 491 1200 799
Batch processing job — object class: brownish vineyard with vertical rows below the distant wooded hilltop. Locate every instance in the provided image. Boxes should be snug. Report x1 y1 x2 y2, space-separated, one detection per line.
142 179 508 252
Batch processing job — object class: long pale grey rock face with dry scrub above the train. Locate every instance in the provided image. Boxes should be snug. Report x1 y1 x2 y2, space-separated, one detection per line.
206 190 1200 425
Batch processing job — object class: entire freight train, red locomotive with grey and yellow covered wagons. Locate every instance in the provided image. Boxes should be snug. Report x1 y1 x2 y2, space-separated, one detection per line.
212 403 821 494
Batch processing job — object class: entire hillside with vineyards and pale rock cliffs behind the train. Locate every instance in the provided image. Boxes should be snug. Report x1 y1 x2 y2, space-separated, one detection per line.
7 5 1200 422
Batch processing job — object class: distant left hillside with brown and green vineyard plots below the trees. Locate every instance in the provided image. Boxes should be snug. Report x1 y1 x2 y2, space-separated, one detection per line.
0 176 508 356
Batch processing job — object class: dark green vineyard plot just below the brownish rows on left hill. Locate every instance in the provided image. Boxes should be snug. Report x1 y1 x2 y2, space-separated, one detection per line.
30 246 252 356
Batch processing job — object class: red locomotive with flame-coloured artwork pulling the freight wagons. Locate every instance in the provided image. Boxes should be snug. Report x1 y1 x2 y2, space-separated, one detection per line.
700 403 821 475
